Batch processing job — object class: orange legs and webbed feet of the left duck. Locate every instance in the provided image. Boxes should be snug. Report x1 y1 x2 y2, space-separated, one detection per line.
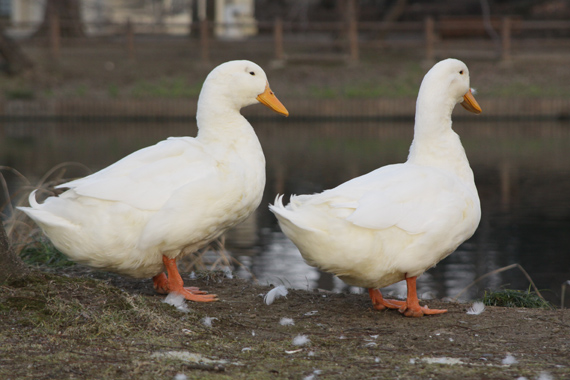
152 255 218 302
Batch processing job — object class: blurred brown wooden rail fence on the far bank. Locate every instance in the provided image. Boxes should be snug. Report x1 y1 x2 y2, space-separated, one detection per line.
12 15 570 63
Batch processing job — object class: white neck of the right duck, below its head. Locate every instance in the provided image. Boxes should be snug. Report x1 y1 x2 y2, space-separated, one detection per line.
407 90 474 186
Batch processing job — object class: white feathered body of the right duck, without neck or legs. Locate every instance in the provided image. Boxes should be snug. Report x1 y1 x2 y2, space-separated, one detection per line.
272 157 480 288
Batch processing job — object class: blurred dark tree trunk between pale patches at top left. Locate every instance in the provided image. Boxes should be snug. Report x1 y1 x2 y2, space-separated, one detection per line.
34 0 85 37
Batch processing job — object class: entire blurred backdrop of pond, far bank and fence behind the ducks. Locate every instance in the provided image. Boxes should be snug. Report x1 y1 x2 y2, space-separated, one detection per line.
0 0 570 304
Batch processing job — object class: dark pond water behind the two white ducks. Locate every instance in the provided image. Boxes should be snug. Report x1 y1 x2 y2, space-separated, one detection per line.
0 118 570 304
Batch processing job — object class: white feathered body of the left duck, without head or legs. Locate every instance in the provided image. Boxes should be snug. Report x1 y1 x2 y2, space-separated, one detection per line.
21 128 265 277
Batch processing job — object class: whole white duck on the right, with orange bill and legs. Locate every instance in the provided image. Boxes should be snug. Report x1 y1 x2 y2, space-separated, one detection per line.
270 59 481 317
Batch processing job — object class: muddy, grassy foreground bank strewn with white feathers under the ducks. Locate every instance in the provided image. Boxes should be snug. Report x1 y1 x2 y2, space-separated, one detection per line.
0 266 570 379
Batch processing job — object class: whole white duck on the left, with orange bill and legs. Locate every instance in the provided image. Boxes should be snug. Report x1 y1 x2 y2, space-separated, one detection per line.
20 61 289 302
